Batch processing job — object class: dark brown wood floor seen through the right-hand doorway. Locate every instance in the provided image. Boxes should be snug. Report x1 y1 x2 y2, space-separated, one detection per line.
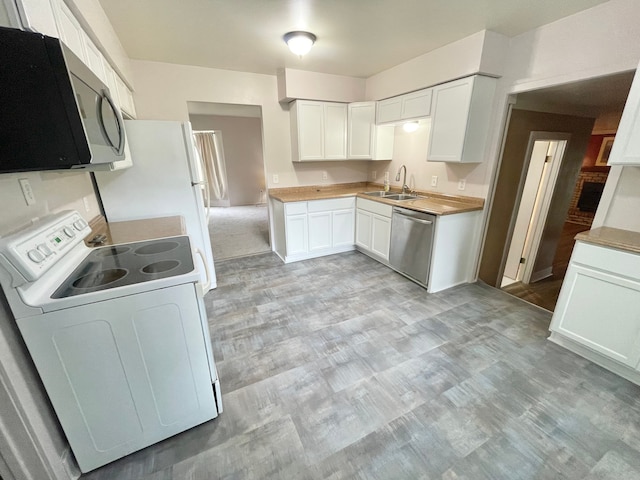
502 222 591 312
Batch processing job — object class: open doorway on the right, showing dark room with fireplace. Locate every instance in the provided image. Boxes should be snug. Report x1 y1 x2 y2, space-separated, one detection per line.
479 72 634 310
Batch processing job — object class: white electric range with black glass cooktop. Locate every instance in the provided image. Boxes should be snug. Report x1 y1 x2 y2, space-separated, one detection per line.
0 211 222 472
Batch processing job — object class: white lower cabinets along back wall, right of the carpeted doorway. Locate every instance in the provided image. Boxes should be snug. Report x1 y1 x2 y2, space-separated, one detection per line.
271 197 355 263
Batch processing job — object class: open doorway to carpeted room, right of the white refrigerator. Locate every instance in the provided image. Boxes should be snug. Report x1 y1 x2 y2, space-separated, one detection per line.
188 102 271 261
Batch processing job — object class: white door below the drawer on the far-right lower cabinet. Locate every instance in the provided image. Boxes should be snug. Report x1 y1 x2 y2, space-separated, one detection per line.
550 263 640 368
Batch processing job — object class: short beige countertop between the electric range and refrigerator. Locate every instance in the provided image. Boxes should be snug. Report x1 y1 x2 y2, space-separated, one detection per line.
85 215 186 247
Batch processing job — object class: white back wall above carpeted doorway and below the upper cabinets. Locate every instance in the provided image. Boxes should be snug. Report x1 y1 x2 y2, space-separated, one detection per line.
131 60 368 188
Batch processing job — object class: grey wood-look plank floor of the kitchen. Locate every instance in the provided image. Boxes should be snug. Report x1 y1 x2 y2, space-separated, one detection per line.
82 252 640 480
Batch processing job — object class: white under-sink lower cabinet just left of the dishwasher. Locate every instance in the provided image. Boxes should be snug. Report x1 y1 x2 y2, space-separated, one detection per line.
356 198 393 263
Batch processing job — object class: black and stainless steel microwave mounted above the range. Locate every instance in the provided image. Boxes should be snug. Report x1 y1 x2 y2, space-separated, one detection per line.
0 28 125 173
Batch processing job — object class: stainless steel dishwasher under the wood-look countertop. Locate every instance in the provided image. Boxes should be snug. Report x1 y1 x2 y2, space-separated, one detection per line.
389 207 436 286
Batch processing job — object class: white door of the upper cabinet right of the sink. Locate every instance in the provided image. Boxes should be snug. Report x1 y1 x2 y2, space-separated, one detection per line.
427 78 473 162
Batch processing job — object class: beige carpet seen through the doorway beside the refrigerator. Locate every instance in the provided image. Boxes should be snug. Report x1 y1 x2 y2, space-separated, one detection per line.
209 205 271 260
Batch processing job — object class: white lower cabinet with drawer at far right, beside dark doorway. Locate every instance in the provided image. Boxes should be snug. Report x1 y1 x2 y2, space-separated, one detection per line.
549 241 640 383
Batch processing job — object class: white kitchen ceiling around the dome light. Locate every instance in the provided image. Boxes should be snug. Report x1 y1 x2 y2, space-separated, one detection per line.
99 0 606 78
